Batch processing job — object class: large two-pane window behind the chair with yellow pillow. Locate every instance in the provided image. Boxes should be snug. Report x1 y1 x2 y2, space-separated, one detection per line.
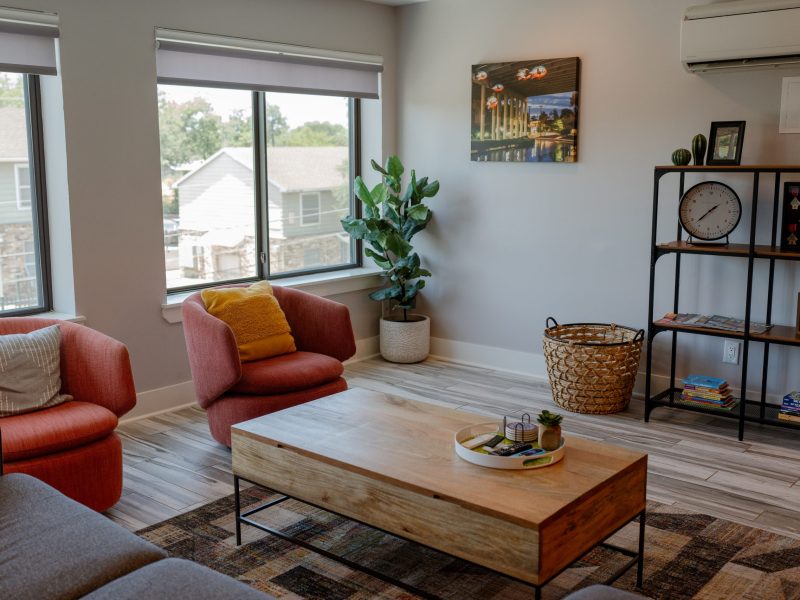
158 84 358 291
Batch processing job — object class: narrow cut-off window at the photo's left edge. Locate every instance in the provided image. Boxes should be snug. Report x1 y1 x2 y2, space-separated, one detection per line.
0 73 50 316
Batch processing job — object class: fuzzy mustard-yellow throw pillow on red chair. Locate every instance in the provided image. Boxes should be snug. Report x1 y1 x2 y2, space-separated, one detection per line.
201 281 297 362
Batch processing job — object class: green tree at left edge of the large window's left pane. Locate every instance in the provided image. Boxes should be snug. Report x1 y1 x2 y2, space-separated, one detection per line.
158 93 223 175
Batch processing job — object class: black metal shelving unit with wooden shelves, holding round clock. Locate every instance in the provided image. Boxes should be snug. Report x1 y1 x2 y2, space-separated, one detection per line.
644 165 800 440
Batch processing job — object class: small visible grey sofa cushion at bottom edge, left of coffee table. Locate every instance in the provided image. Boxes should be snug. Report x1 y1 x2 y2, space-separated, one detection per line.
83 558 274 600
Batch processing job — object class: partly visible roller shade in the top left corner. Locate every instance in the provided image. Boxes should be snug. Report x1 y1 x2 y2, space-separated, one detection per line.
0 7 58 75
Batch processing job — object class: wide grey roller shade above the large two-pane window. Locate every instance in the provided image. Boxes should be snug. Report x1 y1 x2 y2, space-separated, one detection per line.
156 29 383 98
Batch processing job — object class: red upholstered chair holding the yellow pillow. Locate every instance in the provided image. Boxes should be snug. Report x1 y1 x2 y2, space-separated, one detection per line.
183 286 356 447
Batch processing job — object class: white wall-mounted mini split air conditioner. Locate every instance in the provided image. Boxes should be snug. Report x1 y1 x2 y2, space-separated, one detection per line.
681 0 800 73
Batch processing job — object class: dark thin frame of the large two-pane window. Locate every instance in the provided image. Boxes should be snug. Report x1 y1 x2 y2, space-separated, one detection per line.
165 85 363 295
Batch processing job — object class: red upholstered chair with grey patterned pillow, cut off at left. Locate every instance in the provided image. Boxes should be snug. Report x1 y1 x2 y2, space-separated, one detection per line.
0 317 136 511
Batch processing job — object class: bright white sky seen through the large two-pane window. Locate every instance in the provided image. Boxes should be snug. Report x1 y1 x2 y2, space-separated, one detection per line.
158 85 348 128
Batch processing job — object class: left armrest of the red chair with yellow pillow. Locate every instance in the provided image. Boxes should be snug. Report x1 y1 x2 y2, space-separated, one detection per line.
181 293 242 408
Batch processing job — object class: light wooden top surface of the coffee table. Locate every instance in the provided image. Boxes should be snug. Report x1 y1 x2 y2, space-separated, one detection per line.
233 388 647 528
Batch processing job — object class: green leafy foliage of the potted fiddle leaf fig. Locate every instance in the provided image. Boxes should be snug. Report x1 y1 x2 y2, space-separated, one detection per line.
342 156 439 321
